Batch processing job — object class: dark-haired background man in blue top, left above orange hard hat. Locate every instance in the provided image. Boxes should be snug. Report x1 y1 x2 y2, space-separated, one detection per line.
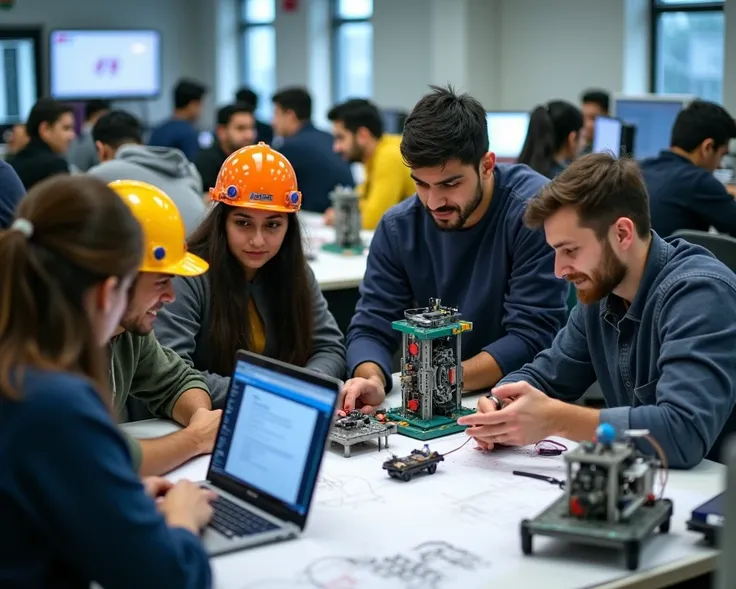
148 80 207 161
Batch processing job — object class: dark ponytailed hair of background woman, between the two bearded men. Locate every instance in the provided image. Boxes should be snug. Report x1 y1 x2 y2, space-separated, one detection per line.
518 100 583 176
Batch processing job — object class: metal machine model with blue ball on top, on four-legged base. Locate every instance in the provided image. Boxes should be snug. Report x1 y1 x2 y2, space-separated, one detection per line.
521 424 672 570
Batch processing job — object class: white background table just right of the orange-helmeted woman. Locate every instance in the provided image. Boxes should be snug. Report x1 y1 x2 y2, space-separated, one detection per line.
299 211 373 291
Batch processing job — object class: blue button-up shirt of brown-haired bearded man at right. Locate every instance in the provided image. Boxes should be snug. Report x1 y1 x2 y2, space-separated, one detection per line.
501 233 736 468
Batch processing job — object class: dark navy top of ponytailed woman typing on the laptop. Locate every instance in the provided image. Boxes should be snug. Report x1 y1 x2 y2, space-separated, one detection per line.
0 370 212 589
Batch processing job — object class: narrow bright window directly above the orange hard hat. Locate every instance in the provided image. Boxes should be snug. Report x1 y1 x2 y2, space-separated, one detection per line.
240 0 276 120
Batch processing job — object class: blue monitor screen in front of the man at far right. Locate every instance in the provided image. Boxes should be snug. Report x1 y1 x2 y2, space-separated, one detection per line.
613 95 694 159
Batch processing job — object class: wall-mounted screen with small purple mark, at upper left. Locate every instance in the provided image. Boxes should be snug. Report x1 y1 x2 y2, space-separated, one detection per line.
49 30 161 100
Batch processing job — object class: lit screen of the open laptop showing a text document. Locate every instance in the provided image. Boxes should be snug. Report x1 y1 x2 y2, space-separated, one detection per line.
211 360 335 514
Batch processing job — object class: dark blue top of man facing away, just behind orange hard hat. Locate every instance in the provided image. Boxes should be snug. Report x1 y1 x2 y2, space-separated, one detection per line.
279 123 355 213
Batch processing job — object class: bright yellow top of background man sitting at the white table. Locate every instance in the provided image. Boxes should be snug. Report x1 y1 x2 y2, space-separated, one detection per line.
359 134 416 229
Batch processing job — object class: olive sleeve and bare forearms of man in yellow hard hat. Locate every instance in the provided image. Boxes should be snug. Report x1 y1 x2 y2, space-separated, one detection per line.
131 334 222 475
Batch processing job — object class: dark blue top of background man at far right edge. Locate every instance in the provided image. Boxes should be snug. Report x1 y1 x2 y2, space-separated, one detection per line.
640 151 736 237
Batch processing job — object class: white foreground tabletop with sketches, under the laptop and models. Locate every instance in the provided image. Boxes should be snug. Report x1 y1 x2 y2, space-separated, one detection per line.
124 387 725 589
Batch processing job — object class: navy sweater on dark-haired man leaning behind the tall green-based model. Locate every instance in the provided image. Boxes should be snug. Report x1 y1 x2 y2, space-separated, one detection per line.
347 165 569 383
